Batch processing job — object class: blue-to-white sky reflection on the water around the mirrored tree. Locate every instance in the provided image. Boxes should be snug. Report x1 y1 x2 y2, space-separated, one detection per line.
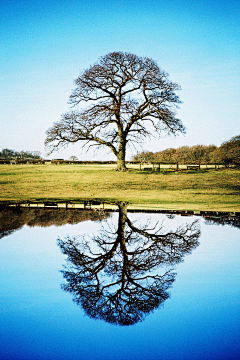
0 205 240 359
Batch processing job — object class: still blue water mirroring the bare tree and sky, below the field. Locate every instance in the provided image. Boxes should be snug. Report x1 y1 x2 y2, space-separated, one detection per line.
0 204 240 360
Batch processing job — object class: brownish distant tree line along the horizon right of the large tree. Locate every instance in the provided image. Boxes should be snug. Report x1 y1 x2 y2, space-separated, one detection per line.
132 135 240 166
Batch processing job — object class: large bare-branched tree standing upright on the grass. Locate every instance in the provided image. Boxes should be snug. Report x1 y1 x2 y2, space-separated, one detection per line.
45 52 185 170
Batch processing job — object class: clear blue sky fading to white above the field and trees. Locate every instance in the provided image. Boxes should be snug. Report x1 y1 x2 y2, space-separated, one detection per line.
0 0 240 159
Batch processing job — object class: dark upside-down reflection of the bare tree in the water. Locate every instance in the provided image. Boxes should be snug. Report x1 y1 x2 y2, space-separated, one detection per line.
58 202 200 325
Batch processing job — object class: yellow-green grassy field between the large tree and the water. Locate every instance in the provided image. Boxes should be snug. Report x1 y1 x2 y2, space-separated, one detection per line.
0 164 240 211
